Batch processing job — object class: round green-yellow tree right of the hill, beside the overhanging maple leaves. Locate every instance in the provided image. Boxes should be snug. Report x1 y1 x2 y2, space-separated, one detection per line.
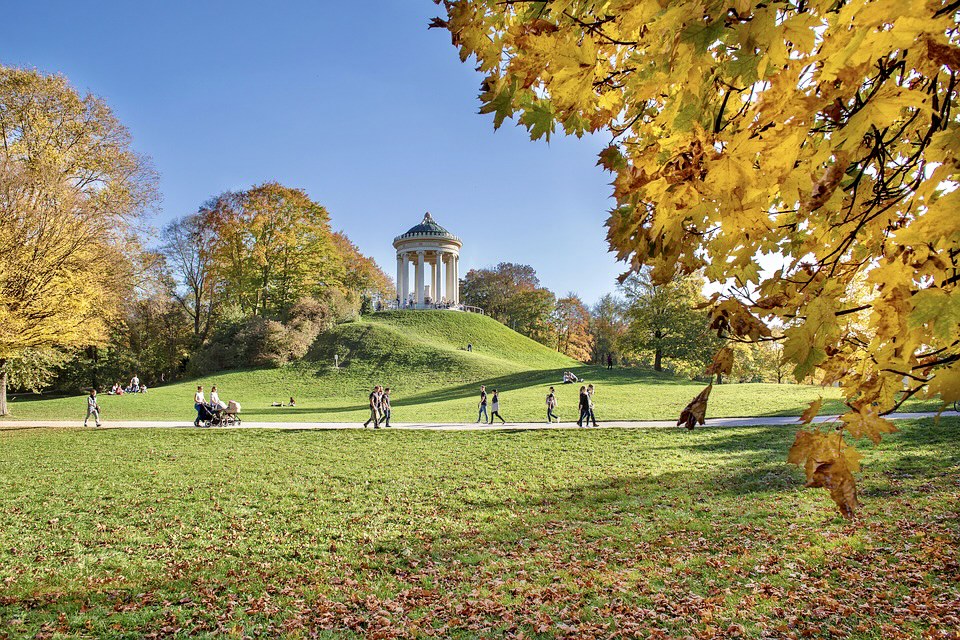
621 269 720 374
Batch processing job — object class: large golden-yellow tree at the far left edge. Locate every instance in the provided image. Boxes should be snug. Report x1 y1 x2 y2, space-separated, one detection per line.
0 67 155 415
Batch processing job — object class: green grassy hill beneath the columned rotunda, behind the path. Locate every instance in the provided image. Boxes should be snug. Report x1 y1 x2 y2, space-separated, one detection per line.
0 311 932 422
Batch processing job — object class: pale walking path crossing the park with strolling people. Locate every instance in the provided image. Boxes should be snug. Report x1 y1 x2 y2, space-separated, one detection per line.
0 411 960 431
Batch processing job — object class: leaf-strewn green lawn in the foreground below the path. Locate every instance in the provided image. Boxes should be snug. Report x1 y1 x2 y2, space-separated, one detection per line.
0 418 960 638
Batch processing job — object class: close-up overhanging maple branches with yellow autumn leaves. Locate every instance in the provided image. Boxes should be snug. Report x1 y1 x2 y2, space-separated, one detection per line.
432 0 960 515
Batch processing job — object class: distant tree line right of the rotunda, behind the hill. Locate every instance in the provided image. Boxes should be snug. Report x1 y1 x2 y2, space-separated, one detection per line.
461 262 788 382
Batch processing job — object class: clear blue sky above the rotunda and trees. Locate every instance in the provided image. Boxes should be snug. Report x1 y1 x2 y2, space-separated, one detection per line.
0 0 622 303
